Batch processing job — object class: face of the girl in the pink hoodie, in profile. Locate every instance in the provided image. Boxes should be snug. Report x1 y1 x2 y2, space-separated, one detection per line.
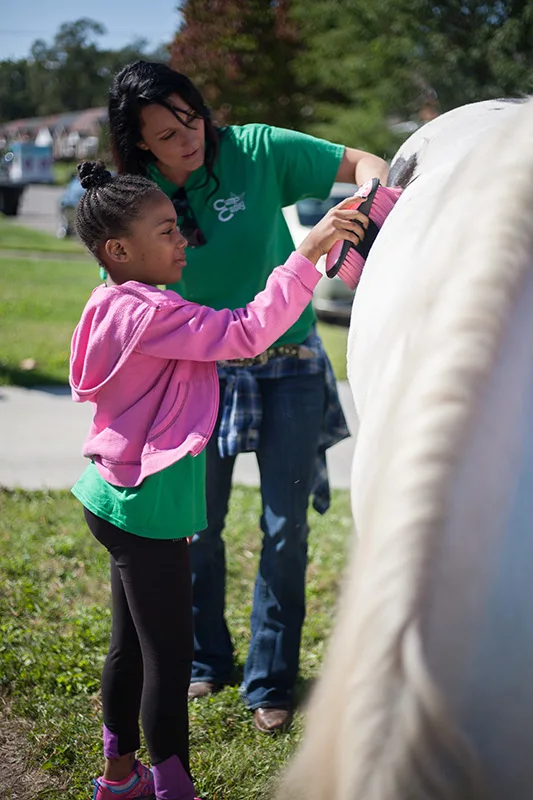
102 191 187 286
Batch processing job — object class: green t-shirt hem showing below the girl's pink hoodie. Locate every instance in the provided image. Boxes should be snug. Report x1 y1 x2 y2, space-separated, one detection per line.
72 450 207 539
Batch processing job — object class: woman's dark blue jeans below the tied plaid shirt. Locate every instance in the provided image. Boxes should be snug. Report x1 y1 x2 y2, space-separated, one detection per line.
190 373 325 709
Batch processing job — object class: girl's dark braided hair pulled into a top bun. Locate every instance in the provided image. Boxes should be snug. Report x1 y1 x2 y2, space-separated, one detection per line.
76 161 160 261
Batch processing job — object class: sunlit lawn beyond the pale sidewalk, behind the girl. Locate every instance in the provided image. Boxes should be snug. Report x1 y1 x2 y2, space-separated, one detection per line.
0 218 347 386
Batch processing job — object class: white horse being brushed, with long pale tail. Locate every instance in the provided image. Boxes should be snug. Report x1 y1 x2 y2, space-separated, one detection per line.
278 101 533 800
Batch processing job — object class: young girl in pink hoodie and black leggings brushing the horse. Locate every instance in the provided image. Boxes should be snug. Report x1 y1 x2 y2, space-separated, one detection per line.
70 162 368 800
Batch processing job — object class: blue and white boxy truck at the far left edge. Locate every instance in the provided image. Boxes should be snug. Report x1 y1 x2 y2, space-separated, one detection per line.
0 142 54 217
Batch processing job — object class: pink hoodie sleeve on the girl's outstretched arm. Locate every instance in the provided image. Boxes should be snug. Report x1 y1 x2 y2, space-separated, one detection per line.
136 253 320 361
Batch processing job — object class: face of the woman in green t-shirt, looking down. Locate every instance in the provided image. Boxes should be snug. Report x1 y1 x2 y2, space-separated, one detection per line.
138 94 205 185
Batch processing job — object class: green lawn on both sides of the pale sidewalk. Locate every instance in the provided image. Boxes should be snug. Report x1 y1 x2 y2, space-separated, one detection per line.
0 220 351 800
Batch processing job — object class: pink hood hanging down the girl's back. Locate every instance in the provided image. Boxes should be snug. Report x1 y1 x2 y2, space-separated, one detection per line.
69 281 157 403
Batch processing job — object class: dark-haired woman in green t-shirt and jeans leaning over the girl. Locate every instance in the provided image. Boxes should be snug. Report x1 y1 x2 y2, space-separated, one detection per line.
109 61 388 733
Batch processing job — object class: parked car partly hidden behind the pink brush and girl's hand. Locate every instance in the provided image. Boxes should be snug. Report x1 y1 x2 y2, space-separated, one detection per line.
283 183 357 325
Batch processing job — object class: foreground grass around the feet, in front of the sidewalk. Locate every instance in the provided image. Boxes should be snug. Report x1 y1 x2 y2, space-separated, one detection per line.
0 487 351 800
